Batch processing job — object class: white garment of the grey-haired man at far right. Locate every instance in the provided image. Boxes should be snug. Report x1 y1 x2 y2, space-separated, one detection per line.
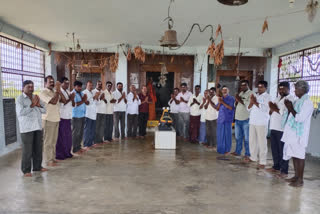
281 99 314 160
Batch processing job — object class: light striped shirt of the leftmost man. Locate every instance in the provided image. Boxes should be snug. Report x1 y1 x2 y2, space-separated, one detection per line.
16 93 46 133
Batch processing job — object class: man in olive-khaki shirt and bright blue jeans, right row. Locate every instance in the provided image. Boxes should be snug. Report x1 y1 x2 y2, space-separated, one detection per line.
232 80 253 161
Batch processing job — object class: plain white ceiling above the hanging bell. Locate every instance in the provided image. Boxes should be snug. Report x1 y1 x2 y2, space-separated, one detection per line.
0 0 320 48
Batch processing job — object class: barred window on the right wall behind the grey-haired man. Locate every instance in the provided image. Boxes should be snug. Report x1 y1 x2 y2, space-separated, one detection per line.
278 46 320 108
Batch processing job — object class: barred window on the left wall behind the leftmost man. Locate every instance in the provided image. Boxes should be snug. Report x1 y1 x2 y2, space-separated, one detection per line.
0 36 44 98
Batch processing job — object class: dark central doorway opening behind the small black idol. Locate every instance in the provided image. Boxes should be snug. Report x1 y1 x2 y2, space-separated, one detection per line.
146 72 174 119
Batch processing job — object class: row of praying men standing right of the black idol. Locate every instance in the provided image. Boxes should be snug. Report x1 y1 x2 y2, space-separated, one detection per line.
169 80 313 187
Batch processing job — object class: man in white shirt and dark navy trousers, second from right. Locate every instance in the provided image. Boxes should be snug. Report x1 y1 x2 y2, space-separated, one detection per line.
267 82 294 178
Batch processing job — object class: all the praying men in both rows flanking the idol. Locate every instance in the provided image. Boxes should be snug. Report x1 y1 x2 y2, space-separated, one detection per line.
16 76 313 186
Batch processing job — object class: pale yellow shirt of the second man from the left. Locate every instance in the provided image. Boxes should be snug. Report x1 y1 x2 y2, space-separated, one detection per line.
39 88 60 122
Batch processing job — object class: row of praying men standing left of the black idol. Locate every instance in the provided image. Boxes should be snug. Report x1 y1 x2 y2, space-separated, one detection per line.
16 76 152 177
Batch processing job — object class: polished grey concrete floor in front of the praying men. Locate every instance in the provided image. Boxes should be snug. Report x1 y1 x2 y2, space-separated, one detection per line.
0 136 320 214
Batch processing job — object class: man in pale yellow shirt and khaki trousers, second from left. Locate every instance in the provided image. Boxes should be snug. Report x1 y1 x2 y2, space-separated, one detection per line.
39 76 66 166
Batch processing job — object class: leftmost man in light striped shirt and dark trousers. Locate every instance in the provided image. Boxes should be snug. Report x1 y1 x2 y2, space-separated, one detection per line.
16 80 47 177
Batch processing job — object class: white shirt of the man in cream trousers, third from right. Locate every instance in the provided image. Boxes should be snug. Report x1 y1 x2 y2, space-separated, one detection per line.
248 92 271 126
